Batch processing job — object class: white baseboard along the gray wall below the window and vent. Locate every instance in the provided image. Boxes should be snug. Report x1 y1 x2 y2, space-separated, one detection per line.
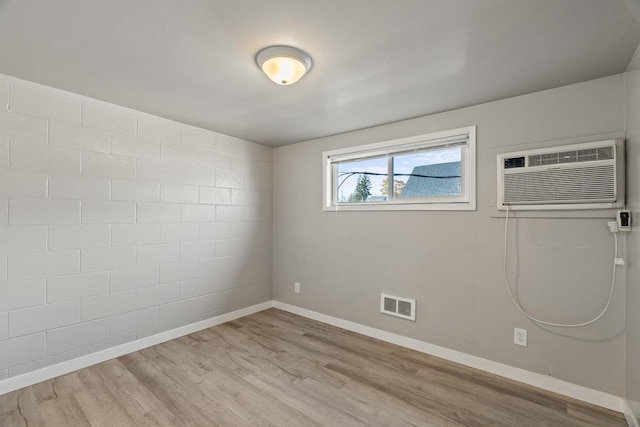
273 301 628 416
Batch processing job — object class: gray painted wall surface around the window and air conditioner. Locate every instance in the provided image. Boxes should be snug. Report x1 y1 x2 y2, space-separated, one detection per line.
273 76 625 396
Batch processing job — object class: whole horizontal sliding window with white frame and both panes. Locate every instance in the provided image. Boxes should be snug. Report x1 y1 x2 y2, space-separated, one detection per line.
323 126 476 210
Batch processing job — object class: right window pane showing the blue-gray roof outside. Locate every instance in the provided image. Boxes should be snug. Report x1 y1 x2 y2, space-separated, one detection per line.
393 147 462 197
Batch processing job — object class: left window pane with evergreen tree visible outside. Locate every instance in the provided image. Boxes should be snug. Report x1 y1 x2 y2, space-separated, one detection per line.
335 157 388 203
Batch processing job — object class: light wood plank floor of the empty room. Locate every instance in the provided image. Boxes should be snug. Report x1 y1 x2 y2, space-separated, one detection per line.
0 309 626 427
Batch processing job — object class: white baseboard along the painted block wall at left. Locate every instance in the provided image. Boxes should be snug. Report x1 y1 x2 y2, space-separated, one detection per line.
0 301 273 395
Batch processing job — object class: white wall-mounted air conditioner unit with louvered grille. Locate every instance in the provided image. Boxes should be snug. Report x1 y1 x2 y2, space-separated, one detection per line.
498 139 625 210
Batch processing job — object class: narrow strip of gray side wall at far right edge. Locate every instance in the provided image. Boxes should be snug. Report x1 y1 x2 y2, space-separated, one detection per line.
625 47 640 420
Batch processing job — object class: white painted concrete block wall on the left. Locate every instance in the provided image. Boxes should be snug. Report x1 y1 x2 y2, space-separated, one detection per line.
0 75 272 380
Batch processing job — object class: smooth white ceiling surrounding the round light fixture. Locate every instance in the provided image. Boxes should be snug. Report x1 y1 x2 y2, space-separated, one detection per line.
0 0 640 146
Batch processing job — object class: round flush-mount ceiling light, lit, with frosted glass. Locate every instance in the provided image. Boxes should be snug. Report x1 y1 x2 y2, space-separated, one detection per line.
256 46 313 86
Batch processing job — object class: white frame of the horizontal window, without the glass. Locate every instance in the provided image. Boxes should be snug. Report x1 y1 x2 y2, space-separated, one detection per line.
322 126 476 211
